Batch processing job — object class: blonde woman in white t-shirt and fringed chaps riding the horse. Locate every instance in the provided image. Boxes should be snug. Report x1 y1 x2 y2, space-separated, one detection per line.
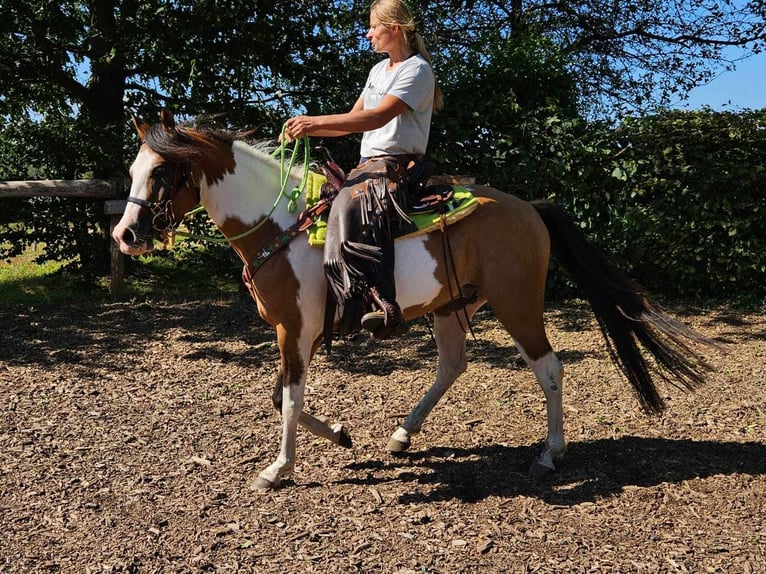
285 0 442 339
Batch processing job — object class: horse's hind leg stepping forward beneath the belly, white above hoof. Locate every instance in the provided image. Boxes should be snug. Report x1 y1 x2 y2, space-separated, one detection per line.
387 305 479 453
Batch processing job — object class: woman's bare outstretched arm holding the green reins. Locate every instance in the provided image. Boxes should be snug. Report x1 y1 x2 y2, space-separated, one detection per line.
285 95 407 140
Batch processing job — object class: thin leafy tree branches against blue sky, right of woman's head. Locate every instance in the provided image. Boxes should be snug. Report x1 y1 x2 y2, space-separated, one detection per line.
419 0 766 116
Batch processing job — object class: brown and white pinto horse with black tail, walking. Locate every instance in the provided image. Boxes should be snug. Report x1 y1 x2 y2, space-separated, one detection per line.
112 110 715 491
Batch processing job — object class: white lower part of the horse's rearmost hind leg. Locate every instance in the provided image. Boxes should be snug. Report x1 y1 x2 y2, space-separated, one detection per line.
516 343 566 470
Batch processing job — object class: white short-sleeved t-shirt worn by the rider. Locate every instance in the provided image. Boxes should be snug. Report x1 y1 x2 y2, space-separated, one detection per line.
360 54 436 157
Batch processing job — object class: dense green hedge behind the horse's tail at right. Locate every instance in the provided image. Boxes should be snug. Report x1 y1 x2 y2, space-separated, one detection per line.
554 110 766 304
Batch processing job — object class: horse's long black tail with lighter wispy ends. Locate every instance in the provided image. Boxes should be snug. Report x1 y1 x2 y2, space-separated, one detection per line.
531 200 718 413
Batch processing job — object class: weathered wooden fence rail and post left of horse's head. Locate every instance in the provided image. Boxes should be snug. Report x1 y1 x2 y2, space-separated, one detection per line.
0 179 128 299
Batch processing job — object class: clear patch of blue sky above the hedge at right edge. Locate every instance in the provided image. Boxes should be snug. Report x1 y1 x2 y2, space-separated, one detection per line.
672 52 766 112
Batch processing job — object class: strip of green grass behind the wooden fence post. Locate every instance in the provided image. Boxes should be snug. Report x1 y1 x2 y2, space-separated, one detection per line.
0 242 239 305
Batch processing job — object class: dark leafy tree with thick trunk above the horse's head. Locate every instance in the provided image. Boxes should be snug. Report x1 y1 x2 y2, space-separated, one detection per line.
0 0 368 276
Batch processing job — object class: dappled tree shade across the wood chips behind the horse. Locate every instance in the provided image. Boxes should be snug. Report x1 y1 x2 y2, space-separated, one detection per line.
0 298 594 375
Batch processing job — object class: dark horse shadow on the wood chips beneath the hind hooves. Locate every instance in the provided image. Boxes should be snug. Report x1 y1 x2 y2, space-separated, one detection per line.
340 436 766 506
